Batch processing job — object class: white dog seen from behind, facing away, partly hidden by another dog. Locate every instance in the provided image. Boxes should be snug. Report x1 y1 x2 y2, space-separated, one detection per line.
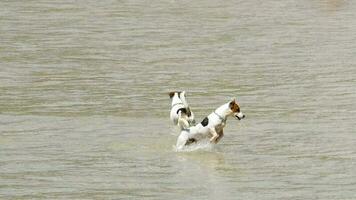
169 91 195 130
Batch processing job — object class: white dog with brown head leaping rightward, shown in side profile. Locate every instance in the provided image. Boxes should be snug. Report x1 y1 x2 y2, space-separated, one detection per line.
176 99 245 150
